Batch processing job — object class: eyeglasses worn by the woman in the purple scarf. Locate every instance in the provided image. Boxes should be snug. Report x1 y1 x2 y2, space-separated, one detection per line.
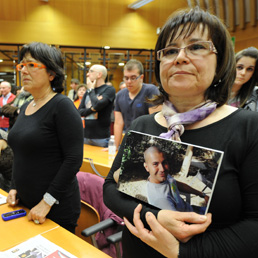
157 41 218 61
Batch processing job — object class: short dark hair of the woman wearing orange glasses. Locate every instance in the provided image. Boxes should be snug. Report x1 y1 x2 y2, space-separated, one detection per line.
19 42 65 93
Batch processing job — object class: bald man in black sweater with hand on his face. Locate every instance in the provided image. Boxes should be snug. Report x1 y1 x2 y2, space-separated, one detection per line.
79 65 116 147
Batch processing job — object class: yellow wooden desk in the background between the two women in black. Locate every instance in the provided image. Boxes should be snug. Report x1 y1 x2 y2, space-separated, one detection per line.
80 144 114 177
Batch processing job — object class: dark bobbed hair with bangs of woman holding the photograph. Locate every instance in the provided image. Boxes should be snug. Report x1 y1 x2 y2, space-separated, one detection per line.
152 7 236 107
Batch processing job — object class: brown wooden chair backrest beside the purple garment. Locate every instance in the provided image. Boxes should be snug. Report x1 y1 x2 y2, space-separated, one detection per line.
75 200 100 244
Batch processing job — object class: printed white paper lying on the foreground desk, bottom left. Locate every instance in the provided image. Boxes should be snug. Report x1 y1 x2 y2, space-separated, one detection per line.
0 235 77 258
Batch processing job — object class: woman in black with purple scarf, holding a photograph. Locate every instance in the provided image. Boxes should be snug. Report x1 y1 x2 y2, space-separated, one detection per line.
103 8 258 258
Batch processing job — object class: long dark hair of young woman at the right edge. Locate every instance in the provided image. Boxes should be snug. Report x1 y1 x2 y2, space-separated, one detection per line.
236 47 258 107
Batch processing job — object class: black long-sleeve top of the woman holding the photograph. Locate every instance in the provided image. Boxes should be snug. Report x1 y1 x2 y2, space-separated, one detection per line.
103 109 258 258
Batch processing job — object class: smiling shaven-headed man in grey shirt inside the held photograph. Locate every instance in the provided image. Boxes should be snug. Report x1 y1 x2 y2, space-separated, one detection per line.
144 146 207 211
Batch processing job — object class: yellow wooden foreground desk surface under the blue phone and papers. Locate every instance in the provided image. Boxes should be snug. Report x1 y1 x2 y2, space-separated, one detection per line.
0 189 110 258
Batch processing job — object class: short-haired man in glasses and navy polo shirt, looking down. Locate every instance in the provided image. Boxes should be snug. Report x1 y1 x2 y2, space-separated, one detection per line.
114 59 160 149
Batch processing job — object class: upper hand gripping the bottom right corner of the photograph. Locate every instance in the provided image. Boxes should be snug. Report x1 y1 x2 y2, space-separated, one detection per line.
158 210 211 243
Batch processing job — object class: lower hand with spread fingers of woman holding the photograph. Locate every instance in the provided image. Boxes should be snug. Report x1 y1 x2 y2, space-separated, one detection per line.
124 204 179 258
